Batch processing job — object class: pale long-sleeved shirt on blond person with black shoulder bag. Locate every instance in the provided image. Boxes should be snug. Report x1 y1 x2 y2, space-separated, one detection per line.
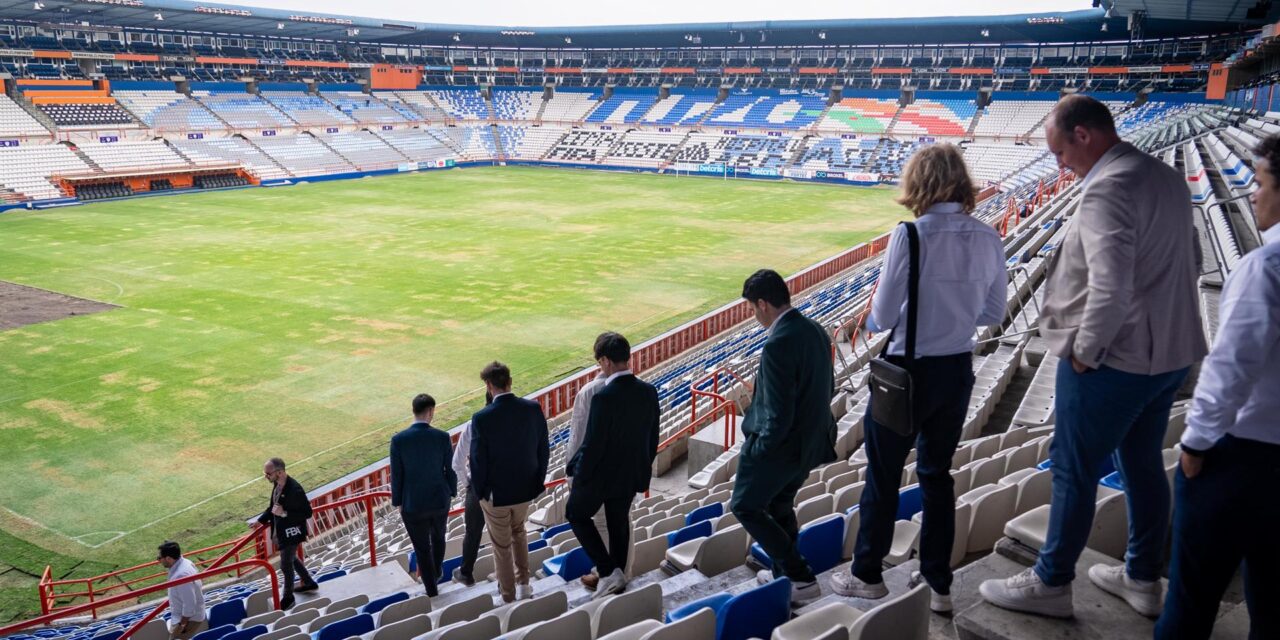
867 202 1009 357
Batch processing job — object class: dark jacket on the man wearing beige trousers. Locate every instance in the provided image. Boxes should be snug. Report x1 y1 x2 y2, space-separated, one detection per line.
468 393 550 507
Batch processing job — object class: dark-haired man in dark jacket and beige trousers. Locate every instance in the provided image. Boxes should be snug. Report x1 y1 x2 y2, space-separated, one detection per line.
470 362 550 603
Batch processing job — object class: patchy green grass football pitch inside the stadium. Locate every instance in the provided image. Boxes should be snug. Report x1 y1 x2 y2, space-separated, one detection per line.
0 168 904 620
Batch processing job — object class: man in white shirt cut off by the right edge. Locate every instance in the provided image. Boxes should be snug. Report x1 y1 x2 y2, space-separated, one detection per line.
1156 136 1280 640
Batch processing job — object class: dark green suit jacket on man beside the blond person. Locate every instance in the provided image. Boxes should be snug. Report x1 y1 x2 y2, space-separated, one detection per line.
742 310 836 472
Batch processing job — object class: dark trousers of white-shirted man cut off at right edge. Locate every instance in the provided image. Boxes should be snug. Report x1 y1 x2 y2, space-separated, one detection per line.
1156 435 1280 640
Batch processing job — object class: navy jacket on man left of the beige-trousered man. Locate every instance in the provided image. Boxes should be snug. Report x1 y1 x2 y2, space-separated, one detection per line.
392 422 458 515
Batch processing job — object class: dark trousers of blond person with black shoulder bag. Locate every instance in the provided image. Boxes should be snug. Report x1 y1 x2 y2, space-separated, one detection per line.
852 353 974 594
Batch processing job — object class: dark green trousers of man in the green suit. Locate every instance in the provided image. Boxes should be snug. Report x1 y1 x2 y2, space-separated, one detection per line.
730 455 817 582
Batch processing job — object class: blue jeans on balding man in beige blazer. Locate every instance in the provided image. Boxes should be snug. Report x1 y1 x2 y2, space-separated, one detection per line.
1036 358 1188 586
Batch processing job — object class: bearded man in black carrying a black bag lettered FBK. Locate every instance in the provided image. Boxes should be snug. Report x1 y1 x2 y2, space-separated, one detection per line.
257 458 320 611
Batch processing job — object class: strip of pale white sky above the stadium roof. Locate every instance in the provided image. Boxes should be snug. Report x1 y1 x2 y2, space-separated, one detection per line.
223 0 1092 27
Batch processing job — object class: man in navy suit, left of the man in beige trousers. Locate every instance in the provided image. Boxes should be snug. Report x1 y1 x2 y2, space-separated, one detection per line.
392 393 458 598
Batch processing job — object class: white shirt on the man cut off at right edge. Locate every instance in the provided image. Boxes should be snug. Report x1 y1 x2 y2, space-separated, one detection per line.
1183 225 1280 451
